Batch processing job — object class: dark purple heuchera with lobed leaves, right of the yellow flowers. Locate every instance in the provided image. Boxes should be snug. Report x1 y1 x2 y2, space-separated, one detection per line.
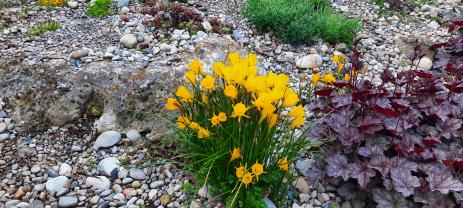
306 19 463 208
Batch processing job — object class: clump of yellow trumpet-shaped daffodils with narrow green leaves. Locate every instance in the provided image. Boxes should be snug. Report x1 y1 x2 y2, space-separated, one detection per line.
166 53 314 207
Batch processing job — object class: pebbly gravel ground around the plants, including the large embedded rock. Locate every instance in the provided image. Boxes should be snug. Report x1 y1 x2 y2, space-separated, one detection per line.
0 0 463 208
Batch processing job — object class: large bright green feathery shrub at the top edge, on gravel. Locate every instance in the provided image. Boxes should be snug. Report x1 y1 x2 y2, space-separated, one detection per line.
242 0 360 43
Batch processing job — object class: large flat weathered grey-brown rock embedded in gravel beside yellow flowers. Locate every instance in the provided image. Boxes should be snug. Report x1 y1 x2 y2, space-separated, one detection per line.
0 34 242 135
